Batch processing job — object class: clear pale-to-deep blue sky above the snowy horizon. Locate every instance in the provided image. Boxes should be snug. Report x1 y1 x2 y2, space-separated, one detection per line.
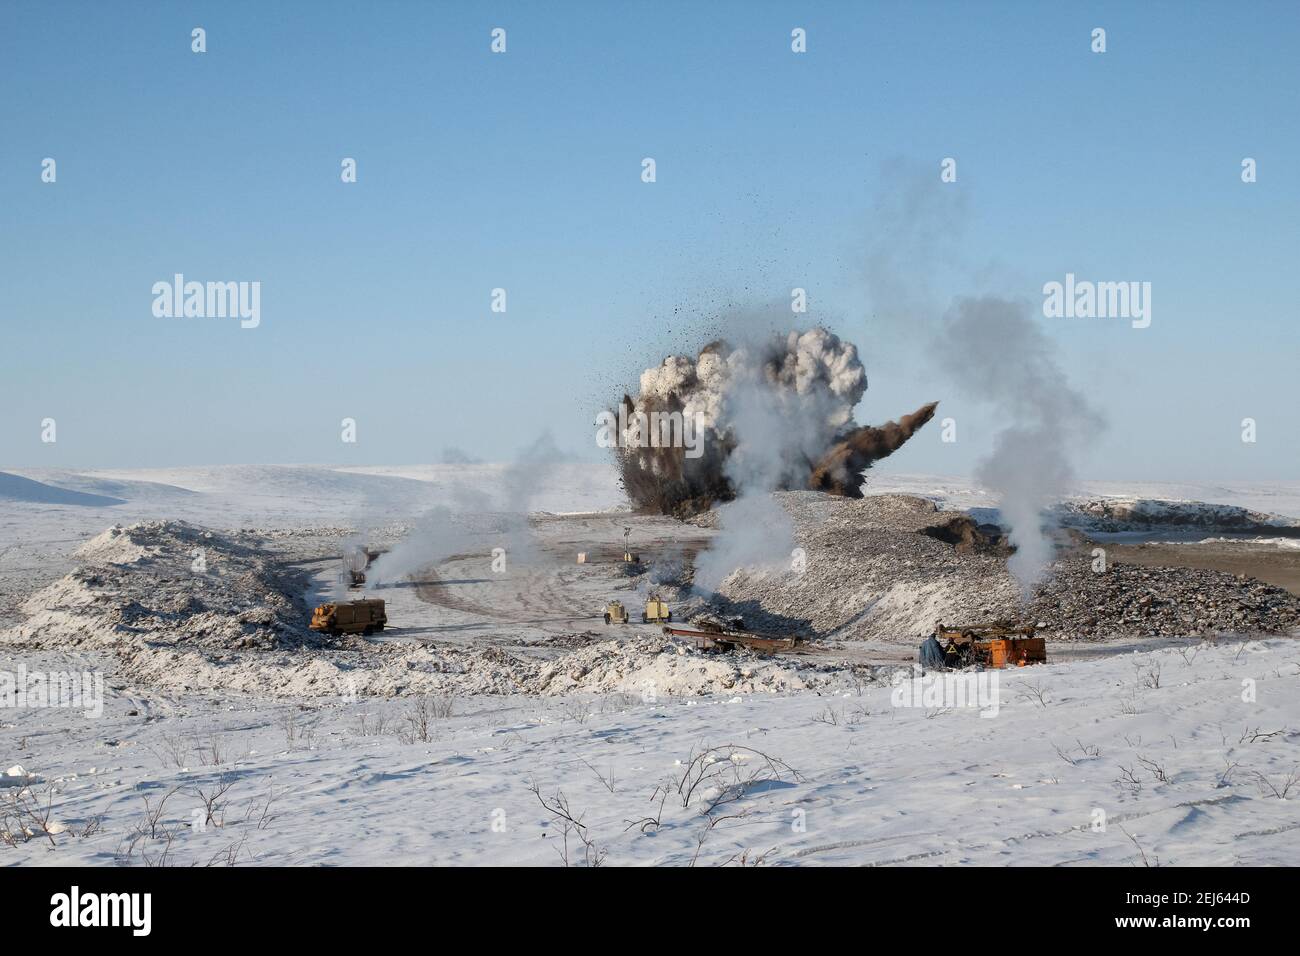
0 1 1300 480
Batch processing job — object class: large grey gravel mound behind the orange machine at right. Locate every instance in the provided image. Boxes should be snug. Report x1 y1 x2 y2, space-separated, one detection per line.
719 492 1300 644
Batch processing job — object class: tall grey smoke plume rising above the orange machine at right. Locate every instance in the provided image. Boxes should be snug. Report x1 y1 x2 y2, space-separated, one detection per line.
866 164 1105 598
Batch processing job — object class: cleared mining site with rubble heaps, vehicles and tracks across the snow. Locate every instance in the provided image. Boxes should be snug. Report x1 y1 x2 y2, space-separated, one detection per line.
0 492 1300 696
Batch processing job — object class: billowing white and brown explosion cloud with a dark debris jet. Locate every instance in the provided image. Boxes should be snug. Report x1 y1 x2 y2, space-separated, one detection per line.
610 328 936 515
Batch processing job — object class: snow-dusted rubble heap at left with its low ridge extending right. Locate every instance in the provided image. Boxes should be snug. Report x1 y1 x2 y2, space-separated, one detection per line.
0 522 872 697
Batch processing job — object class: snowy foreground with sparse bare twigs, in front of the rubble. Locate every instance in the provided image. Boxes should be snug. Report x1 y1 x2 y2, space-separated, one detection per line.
0 640 1300 866
